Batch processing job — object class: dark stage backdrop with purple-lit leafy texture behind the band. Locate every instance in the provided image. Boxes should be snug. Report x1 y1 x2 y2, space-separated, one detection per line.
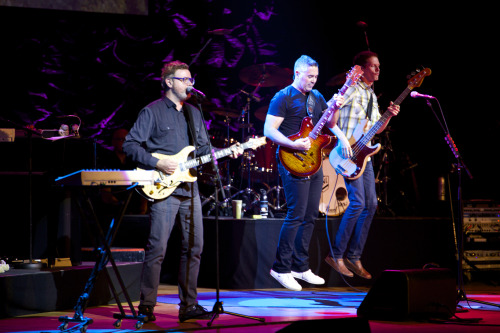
0 0 499 236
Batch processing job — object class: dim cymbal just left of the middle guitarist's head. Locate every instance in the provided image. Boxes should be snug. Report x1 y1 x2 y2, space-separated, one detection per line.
239 64 293 87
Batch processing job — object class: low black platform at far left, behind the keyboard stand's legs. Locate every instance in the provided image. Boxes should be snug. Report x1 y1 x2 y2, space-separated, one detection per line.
0 263 142 318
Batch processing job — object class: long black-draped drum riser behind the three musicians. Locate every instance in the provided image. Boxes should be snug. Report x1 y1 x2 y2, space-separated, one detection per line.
147 218 456 289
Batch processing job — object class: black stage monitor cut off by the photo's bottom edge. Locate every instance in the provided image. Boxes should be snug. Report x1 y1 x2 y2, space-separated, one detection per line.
278 317 370 333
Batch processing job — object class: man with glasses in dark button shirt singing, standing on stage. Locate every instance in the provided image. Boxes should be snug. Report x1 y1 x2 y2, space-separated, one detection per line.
123 61 242 322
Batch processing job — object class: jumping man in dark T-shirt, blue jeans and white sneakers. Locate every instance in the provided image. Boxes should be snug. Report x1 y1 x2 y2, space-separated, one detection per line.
264 55 349 291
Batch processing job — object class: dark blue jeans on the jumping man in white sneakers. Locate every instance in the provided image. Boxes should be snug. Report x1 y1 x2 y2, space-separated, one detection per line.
273 163 323 273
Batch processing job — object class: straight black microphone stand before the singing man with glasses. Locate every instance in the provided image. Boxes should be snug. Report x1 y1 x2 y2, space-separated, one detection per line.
194 101 265 326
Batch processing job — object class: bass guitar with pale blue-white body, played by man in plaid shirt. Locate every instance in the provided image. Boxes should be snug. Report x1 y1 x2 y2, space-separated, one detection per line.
329 68 431 180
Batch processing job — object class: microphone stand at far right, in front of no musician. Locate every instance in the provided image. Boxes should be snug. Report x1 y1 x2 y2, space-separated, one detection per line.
427 98 500 307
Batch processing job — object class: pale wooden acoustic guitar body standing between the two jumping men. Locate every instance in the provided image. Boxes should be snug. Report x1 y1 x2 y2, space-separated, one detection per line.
319 158 349 216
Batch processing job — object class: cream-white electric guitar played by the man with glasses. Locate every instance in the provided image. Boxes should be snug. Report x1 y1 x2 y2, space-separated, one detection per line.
139 136 266 199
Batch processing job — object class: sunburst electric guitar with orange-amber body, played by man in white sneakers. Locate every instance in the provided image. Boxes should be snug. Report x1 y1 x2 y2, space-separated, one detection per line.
278 65 363 177
